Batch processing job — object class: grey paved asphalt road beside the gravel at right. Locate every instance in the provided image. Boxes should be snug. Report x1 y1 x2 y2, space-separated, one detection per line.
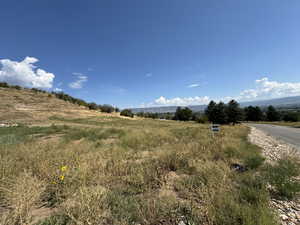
249 124 300 149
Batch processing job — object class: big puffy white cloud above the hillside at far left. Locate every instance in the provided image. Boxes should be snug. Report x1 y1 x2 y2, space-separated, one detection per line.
0 56 55 88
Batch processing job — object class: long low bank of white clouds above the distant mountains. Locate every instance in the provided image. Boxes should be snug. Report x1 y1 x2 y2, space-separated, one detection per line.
143 77 300 107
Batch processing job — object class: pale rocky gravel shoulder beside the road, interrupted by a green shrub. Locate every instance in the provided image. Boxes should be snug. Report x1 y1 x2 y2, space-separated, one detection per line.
248 126 300 225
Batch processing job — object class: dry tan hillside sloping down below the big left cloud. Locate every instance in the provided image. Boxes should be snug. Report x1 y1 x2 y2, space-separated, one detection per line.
0 87 106 124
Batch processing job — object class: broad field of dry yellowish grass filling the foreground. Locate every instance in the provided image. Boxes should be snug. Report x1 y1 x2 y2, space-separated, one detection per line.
0 116 282 225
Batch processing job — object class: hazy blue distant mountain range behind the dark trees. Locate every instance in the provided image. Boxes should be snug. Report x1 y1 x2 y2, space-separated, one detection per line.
131 96 300 113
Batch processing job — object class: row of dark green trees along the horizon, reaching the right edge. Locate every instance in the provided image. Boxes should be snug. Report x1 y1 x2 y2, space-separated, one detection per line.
136 100 300 125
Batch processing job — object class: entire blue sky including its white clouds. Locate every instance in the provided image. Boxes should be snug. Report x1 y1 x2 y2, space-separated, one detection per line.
0 0 300 108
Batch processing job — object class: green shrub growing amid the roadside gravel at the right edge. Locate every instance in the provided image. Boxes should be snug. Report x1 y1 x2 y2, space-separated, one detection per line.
266 159 300 199
